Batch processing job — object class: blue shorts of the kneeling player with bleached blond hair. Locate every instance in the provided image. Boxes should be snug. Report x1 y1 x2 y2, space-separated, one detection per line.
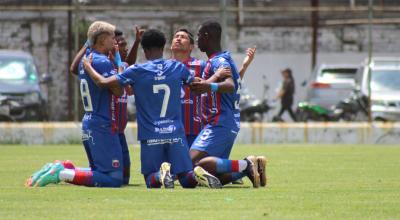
82 123 123 173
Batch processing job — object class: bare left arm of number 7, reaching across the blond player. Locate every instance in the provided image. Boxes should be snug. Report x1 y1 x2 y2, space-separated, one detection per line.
82 55 124 96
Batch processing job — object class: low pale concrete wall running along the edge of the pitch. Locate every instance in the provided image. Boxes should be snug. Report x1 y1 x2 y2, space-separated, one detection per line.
0 122 400 145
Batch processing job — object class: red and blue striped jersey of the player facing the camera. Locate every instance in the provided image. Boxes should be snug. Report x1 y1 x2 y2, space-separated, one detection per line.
182 58 205 135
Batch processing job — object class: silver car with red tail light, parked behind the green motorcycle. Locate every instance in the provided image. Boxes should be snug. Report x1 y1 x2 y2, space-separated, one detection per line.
305 64 359 109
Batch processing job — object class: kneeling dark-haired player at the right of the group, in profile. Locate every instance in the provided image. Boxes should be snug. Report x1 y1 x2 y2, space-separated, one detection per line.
190 22 266 187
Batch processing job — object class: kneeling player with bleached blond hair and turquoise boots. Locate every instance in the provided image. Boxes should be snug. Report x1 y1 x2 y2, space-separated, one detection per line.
27 22 123 187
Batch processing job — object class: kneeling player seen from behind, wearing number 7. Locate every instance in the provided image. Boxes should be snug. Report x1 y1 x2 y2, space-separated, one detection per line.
84 30 221 188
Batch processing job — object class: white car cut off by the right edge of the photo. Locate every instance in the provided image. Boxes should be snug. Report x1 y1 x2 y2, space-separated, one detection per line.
356 57 400 121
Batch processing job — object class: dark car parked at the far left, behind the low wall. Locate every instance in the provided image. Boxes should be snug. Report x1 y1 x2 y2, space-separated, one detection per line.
0 50 51 121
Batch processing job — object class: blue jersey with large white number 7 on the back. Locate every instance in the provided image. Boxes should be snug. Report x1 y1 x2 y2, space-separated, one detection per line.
117 58 194 140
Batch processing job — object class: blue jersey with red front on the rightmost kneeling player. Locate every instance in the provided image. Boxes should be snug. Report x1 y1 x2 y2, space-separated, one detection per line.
201 52 240 131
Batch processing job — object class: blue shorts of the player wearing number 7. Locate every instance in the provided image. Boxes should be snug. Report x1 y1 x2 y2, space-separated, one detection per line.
140 137 193 175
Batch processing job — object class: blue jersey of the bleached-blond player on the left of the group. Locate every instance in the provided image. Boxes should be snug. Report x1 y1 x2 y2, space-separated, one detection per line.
79 50 118 132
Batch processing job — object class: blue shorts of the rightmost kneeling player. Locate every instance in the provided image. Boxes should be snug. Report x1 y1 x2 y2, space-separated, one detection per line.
190 125 237 159
